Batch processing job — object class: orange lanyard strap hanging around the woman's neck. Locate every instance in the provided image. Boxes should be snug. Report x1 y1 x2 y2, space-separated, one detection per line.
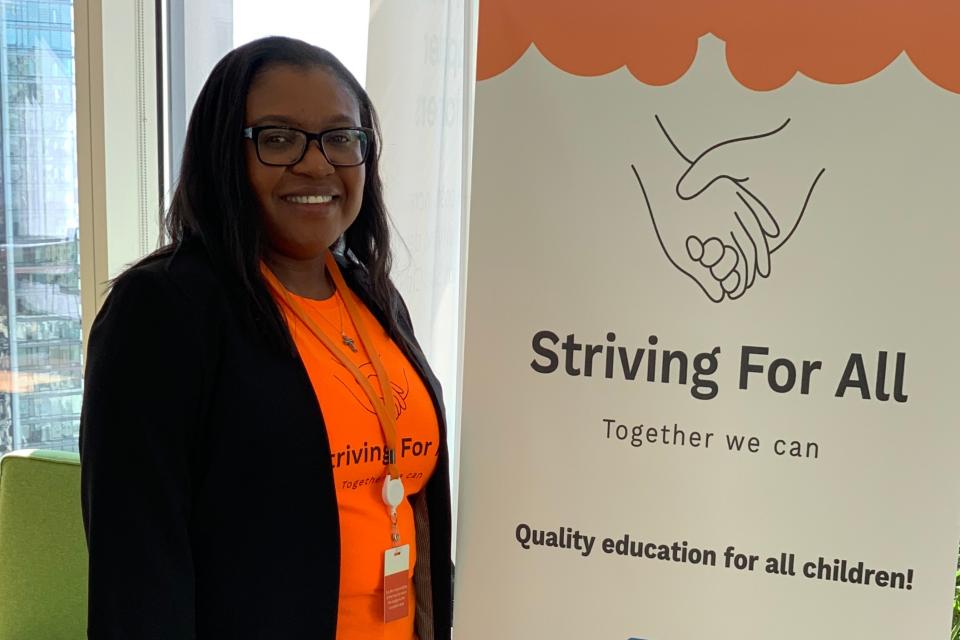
261 251 400 480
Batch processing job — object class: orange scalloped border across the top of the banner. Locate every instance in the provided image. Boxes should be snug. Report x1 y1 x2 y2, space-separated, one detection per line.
477 0 960 93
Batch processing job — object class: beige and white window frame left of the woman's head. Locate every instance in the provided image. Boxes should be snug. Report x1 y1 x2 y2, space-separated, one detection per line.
74 0 160 349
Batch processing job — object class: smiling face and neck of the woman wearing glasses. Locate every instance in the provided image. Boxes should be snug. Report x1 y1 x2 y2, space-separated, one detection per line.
245 65 366 299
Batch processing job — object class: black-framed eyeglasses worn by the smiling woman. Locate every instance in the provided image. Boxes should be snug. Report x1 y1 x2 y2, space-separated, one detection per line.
243 126 373 167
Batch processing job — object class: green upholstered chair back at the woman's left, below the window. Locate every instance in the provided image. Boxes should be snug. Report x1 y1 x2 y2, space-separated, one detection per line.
0 450 87 640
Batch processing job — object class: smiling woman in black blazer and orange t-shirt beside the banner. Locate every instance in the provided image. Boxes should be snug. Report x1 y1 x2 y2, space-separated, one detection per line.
80 37 452 640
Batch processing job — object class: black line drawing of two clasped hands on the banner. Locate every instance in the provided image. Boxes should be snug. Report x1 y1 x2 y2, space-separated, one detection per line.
631 115 825 303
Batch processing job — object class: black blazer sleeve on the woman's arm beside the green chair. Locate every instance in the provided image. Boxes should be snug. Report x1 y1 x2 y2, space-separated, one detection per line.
80 268 204 640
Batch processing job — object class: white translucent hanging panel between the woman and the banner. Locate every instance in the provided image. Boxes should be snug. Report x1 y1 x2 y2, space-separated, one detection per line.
366 0 473 524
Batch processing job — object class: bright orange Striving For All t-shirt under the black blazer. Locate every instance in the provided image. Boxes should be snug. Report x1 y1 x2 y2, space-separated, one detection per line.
279 291 439 640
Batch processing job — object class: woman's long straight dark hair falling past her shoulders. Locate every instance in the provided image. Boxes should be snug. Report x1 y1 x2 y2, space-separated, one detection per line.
161 36 398 346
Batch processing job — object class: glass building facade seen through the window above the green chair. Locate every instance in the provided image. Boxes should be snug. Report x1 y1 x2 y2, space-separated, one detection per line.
0 0 82 453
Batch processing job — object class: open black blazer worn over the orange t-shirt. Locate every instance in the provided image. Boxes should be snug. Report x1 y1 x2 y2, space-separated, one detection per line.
80 241 452 640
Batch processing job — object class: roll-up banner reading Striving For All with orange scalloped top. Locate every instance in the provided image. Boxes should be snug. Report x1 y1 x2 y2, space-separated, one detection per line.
455 0 960 640
